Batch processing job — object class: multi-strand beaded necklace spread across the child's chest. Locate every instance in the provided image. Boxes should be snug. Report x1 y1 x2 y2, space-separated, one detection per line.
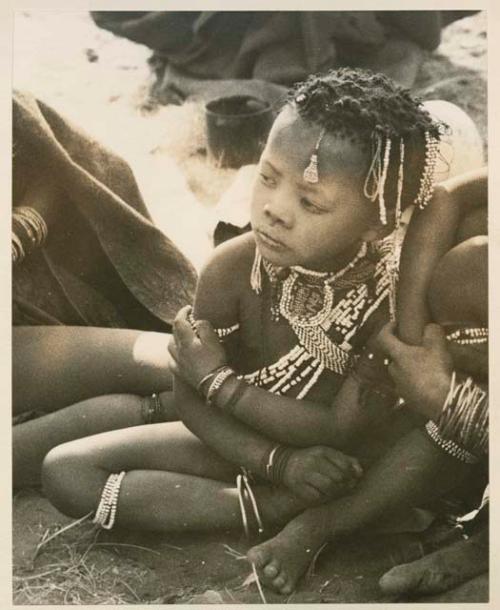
240 240 393 399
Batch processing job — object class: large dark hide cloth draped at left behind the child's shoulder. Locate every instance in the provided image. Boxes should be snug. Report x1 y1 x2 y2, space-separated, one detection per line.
12 92 196 331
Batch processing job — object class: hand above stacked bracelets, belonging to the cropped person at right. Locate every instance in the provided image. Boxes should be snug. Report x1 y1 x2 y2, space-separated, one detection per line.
377 324 453 419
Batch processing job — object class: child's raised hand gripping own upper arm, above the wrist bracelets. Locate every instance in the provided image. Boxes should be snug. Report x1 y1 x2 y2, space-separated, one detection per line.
168 305 227 388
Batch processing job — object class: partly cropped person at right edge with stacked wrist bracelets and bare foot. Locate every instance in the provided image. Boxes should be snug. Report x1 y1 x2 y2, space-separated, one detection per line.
242 168 488 593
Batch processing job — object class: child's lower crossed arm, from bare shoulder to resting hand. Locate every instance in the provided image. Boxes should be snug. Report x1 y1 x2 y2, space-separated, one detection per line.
170 238 359 501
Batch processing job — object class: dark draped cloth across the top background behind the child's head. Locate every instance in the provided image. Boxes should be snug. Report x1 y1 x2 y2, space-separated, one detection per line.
91 11 476 105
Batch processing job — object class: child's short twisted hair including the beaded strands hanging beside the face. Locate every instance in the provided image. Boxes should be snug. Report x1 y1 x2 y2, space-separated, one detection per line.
288 68 446 216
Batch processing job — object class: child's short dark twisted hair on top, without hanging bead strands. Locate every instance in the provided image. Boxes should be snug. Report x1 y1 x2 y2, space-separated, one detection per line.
288 68 444 143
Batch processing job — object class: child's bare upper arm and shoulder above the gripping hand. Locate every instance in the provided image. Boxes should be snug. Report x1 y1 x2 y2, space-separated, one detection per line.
194 232 255 326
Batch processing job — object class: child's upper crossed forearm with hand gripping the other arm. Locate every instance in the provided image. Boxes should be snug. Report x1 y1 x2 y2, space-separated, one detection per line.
172 310 390 450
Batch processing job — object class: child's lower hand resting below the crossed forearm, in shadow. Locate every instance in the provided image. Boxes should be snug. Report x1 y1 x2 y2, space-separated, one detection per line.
283 447 363 503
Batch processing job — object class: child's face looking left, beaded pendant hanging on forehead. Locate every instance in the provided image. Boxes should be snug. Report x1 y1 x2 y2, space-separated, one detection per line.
251 107 380 271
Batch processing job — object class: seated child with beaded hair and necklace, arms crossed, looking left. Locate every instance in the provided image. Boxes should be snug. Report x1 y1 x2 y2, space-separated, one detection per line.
39 69 476 580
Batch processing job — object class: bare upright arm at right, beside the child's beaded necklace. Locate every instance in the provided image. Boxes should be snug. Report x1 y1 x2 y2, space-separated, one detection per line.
397 168 487 344
